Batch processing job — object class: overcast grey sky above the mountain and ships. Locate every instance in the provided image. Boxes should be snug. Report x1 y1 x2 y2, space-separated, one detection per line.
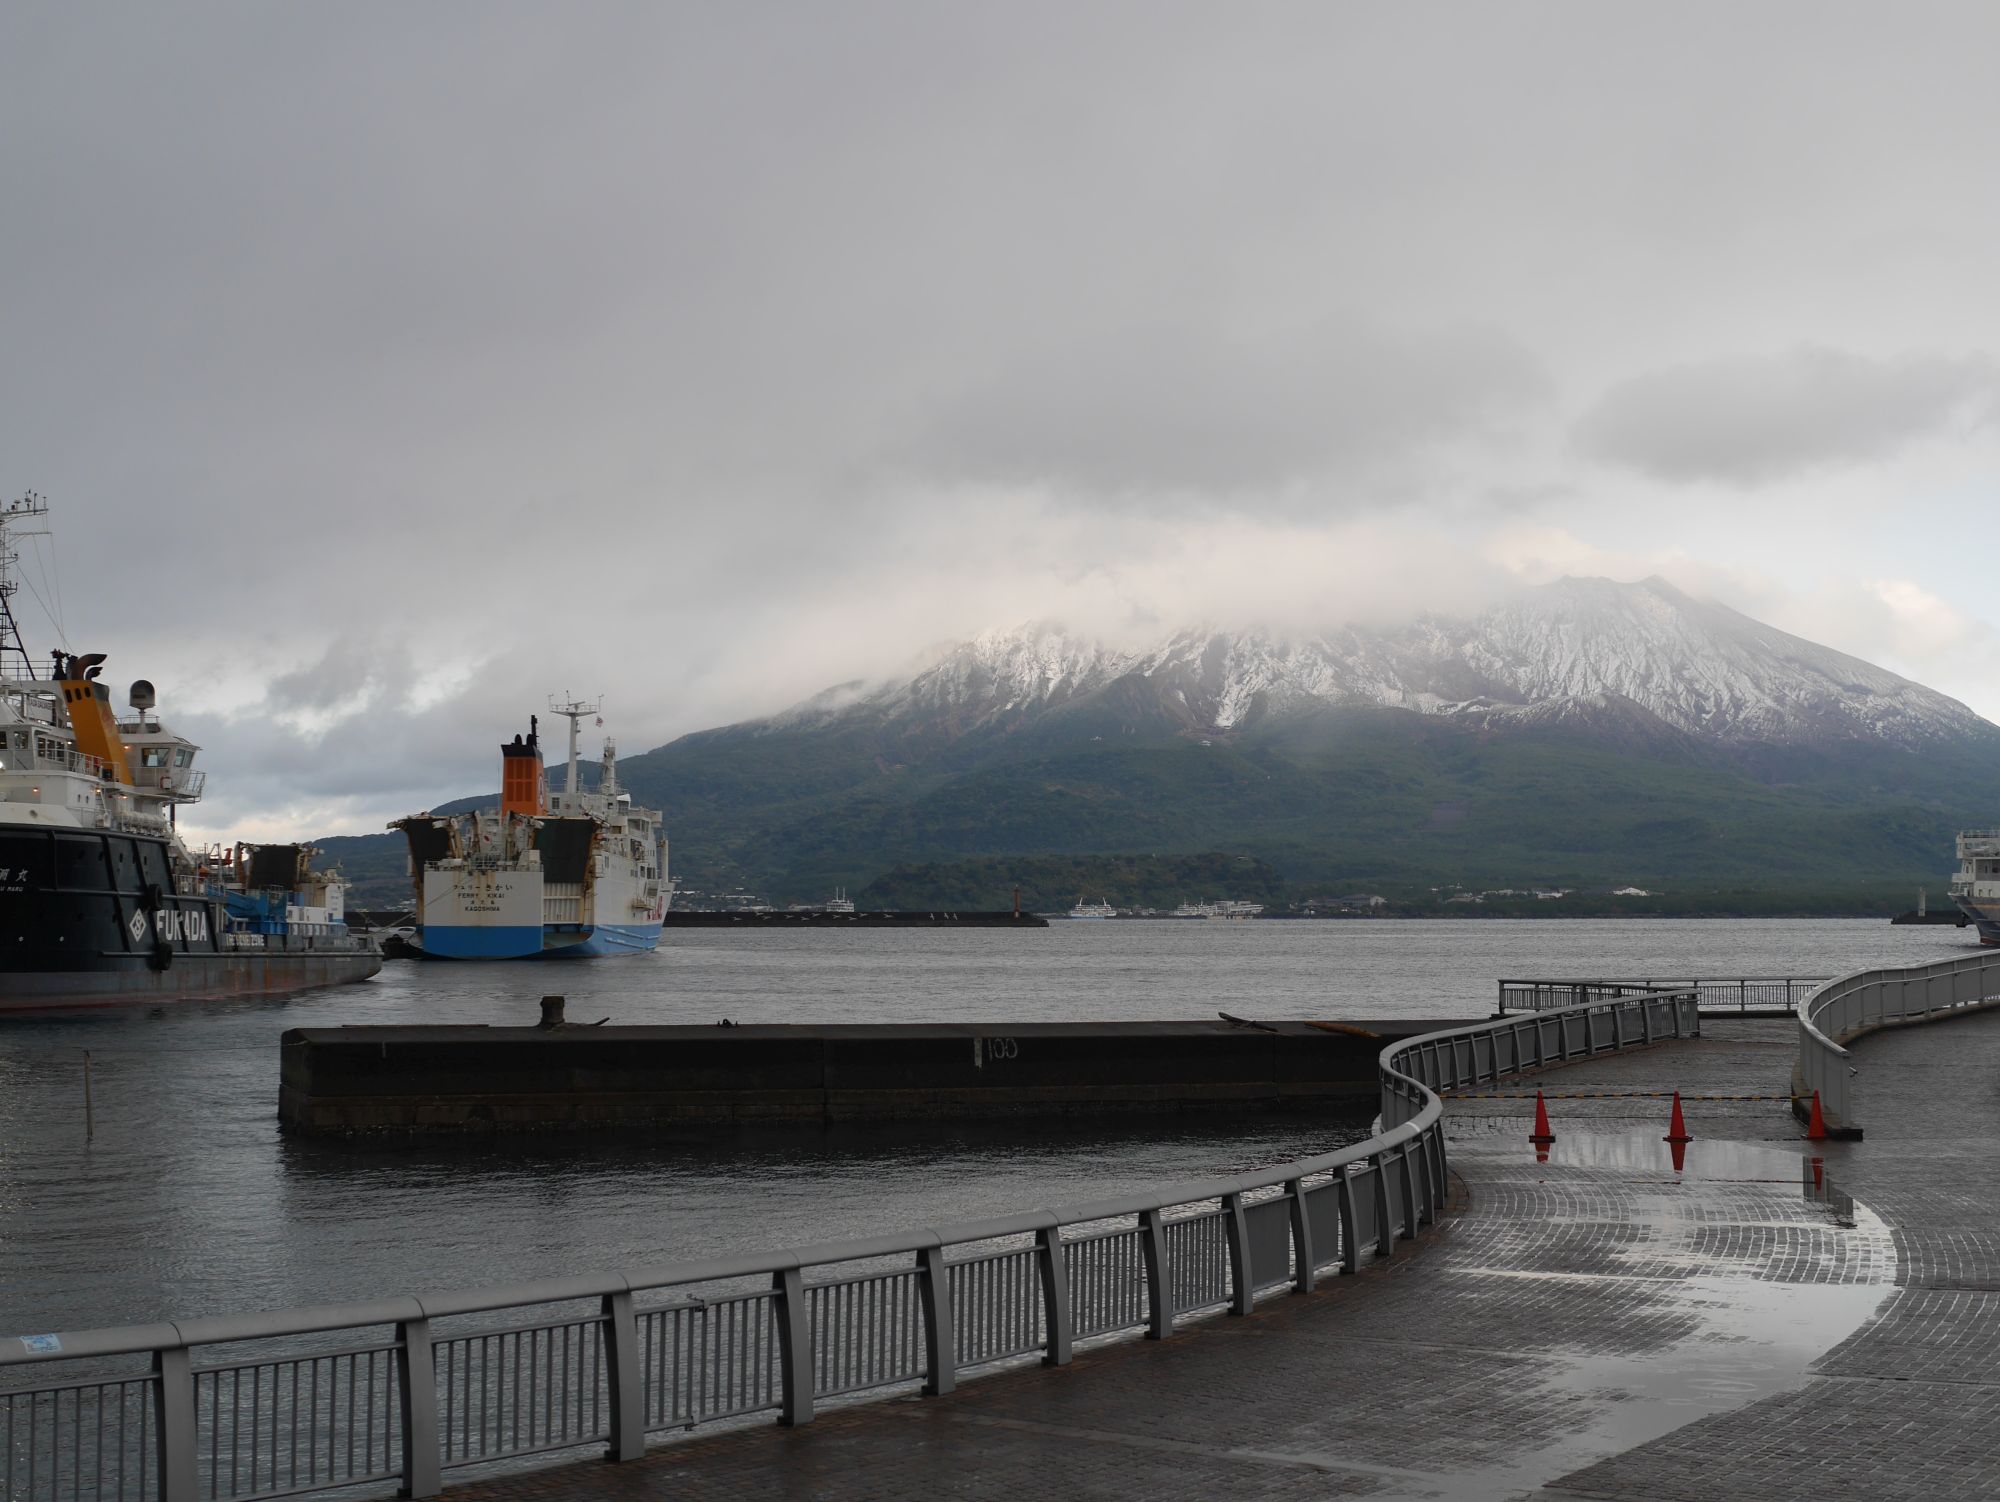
0 0 2000 834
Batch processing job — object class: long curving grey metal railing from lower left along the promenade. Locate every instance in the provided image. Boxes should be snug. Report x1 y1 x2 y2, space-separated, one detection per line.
0 992 1700 1502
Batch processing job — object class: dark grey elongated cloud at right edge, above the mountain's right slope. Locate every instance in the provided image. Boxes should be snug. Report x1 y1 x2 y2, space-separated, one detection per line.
1576 346 2000 484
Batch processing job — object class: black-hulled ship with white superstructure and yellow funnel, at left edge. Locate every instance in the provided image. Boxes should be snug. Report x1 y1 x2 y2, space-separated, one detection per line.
0 494 382 1012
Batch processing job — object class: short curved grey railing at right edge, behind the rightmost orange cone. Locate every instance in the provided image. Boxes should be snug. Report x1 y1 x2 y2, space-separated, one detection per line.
1792 952 2000 1138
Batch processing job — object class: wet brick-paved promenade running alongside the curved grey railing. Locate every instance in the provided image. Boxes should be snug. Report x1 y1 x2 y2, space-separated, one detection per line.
448 1016 2000 1502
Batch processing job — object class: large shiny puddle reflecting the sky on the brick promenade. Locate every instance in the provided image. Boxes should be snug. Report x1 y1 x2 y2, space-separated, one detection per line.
1378 1128 1896 1502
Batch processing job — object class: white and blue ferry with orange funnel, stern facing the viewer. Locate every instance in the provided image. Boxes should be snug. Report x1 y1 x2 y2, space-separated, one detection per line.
390 700 674 960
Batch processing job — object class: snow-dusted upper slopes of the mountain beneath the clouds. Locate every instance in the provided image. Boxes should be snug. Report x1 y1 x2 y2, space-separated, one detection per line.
764 578 1992 748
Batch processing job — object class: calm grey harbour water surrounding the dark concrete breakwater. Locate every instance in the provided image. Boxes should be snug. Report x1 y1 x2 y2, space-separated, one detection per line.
0 920 1972 1334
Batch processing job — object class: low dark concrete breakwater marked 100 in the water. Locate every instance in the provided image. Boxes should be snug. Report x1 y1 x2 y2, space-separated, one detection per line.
278 1016 1460 1136
